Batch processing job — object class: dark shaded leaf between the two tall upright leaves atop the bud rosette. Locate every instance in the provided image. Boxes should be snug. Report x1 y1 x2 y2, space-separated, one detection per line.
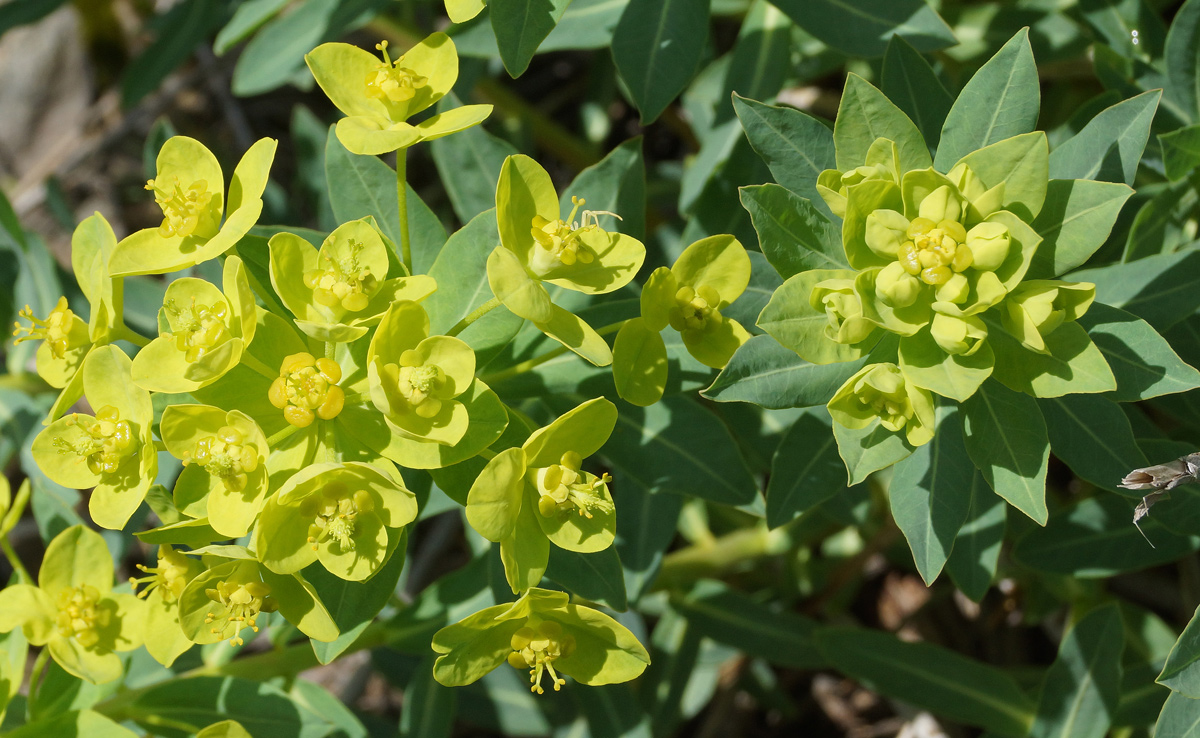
881 35 954 149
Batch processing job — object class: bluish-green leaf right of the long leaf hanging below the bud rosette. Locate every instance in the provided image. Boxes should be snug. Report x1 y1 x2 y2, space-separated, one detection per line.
946 469 1008 602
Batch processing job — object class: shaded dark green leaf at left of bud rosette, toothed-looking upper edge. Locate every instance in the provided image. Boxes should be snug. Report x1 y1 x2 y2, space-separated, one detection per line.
738 185 850 280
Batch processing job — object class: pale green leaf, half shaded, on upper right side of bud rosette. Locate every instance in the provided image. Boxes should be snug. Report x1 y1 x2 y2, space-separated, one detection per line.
1025 179 1133 280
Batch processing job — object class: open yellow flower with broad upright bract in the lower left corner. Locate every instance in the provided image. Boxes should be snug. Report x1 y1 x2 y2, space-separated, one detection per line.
0 526 146 684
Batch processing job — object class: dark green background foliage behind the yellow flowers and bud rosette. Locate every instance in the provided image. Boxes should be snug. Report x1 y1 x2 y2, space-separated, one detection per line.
0 0 1200 738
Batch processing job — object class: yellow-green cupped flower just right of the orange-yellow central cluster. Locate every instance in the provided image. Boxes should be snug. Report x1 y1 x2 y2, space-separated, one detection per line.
367 301 475 445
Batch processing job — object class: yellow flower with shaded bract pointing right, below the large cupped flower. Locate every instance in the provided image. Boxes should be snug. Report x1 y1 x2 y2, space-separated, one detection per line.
179 546 338 646
